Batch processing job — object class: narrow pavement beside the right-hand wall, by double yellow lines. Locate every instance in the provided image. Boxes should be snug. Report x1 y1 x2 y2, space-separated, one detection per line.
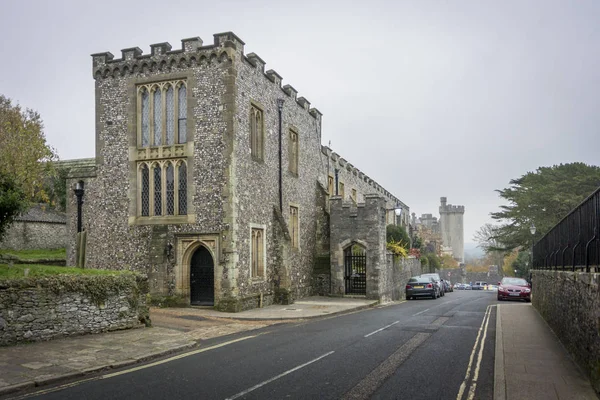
494 303 598 400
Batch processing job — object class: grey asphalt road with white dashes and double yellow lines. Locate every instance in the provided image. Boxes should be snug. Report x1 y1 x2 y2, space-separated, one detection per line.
22 291 496 400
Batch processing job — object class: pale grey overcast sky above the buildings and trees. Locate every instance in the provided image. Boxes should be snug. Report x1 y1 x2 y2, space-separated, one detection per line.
0 0 600 242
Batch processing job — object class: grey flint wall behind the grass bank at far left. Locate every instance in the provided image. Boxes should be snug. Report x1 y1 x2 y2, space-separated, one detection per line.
0 221 67 250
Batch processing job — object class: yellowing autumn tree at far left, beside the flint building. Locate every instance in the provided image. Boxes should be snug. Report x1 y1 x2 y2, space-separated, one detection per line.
0 95 57 202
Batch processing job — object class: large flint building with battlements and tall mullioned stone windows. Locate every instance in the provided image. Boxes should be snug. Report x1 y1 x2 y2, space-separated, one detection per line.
67 32 408 311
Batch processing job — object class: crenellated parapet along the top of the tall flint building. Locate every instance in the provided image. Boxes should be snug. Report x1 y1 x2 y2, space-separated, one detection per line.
92 32 323 121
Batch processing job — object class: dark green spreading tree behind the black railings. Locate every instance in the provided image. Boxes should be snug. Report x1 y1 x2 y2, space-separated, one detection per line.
491 162 600 251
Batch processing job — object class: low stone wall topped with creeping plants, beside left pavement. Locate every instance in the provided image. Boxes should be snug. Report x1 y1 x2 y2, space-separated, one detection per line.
0 274 150 346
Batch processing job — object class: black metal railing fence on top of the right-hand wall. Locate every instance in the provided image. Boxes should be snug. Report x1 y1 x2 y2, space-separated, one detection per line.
533 188 600 272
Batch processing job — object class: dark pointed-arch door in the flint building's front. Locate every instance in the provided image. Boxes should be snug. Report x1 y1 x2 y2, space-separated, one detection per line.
190 246 215 306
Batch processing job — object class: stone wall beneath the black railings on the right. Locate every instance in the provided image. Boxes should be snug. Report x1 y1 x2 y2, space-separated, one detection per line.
532 271 600 393
